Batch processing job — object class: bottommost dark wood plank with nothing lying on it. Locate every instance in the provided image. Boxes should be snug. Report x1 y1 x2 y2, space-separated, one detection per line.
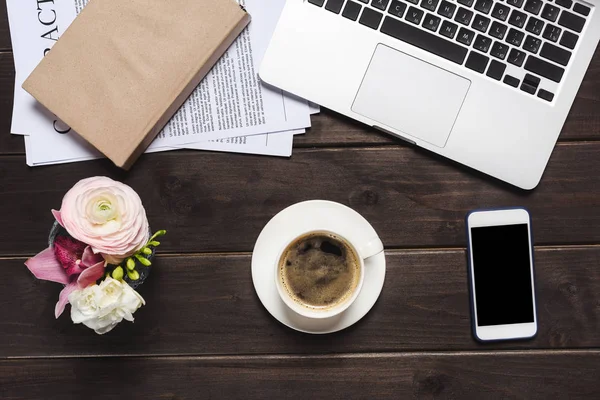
0 351 600 400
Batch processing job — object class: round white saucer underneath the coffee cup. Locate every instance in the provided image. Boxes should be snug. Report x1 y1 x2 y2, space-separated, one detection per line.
252 200 385 334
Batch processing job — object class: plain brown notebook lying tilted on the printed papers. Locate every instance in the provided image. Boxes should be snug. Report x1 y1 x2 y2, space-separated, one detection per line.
23 0 250 169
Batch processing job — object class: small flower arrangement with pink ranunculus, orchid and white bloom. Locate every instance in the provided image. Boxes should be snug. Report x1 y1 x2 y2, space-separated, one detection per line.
25 177 166 335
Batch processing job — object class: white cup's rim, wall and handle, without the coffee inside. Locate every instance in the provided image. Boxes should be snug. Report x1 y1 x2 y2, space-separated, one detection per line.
275 229 383 318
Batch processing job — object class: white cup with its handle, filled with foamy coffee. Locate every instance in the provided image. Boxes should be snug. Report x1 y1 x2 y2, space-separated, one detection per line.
275 229 383 318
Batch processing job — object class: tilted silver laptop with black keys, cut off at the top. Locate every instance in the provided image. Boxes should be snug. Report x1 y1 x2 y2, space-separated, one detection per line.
259 0 600 189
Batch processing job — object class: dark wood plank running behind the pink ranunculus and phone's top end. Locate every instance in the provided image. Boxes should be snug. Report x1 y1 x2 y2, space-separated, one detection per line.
0 143 600 256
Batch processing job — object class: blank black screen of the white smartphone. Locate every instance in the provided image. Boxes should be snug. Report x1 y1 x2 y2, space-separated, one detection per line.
471 224 534 326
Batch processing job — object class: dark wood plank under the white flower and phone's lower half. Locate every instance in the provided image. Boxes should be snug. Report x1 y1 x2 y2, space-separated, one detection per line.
0 246 600 357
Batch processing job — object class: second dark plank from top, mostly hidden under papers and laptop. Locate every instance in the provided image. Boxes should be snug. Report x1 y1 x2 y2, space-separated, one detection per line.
0 45 600 154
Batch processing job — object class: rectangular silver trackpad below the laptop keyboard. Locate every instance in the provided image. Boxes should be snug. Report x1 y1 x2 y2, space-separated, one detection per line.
352 44 471 147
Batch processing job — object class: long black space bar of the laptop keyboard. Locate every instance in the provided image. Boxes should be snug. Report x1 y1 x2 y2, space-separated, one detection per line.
381 17 468 64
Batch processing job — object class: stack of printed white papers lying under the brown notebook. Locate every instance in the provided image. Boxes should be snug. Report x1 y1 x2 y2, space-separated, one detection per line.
7 0 319 166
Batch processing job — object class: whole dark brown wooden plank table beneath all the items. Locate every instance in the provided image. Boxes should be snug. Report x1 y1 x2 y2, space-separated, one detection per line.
0 1 600 400
